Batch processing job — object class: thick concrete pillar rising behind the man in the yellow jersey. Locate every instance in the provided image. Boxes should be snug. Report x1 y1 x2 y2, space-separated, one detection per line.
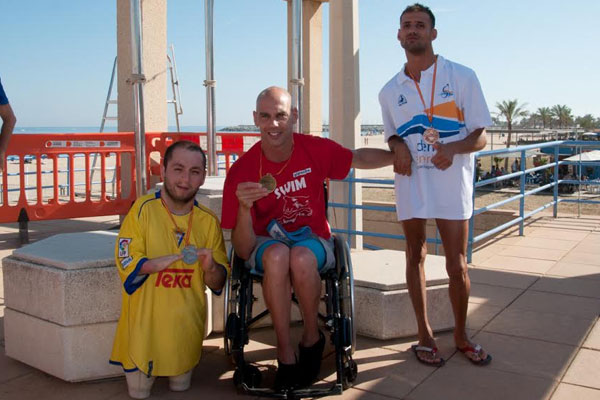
117 0 168 194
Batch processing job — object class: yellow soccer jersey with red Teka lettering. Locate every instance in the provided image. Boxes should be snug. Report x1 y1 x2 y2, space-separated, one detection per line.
110 192 228 376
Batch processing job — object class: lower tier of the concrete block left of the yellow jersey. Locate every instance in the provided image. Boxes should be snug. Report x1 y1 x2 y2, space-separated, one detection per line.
4 308 123 382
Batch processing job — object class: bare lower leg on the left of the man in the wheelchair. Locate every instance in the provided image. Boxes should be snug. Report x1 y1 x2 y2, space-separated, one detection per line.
262 243 296 364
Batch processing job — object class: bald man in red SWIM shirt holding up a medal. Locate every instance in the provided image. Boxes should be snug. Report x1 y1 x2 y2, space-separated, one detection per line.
221 87 393 391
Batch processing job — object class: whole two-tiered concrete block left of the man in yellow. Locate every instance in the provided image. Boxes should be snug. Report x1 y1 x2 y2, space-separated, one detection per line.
2 232 122 381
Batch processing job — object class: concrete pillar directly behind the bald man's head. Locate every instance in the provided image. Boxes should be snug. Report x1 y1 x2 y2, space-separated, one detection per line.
287 0 327 136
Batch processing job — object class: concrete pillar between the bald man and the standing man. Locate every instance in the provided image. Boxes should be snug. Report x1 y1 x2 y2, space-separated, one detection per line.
329 0 362 248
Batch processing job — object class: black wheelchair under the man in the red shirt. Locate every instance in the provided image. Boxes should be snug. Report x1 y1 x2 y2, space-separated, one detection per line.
223 235 358 399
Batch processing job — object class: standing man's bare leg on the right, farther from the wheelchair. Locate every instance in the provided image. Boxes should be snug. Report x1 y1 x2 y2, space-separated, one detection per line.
436 219 487 358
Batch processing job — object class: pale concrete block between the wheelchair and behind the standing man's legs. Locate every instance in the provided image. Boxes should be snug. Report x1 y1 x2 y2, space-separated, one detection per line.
352 250 454 340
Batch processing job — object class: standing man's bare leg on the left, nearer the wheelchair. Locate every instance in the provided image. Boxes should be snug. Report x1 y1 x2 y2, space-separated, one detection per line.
402 218 440 362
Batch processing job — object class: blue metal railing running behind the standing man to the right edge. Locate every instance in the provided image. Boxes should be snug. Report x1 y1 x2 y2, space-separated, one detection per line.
329 140 600 262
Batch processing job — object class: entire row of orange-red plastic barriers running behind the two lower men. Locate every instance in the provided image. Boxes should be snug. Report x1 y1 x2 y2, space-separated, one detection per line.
0 132 260 231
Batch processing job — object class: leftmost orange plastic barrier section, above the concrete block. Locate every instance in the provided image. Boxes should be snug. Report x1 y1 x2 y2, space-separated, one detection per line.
0 132 136 223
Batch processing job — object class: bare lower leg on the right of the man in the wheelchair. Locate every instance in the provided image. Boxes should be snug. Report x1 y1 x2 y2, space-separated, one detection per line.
290 246 321 347
